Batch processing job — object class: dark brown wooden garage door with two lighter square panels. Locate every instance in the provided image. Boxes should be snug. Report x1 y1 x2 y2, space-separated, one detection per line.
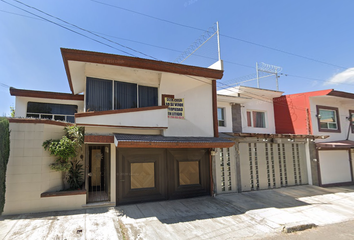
117 149 210 204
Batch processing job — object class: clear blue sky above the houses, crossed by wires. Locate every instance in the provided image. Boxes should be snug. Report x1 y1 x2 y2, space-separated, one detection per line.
0 0 354 115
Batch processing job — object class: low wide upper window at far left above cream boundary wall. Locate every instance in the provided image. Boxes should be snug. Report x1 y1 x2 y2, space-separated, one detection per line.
26 102 77 123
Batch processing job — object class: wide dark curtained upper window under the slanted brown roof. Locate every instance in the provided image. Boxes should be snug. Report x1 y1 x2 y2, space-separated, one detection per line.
86 78 158 111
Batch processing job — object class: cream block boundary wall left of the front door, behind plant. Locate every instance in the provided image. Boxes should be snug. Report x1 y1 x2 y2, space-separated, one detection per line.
3 123 86 215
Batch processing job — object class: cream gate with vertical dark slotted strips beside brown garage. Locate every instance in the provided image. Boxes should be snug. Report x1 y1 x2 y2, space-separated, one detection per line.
216 142 308 193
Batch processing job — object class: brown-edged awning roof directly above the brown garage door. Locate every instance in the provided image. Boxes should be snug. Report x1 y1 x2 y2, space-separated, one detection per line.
114 133 234 148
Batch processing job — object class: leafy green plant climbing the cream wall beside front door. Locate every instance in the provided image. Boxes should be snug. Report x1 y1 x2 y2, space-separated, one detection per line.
43 126 84 189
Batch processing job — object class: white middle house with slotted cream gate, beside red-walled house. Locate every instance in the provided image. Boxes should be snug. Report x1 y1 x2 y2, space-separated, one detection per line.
215 86 324 193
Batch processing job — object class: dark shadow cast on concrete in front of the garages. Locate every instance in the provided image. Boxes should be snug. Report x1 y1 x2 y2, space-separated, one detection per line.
116 186 354 224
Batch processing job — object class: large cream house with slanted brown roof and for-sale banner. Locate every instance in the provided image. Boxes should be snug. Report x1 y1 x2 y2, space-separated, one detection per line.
4 49 233 214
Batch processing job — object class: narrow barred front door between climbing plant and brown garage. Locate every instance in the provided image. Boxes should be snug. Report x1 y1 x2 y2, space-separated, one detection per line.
86 145 110 203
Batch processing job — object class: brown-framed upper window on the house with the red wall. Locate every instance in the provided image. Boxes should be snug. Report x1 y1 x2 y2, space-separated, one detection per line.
317 106 340 132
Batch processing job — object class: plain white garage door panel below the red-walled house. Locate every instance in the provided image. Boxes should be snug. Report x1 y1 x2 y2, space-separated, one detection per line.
318 150 352 185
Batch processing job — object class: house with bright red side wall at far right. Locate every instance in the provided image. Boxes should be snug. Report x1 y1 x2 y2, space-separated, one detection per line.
274 89 354 186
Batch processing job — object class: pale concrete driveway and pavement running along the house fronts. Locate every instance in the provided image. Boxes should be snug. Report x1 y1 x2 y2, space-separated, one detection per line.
0 186 354 239
